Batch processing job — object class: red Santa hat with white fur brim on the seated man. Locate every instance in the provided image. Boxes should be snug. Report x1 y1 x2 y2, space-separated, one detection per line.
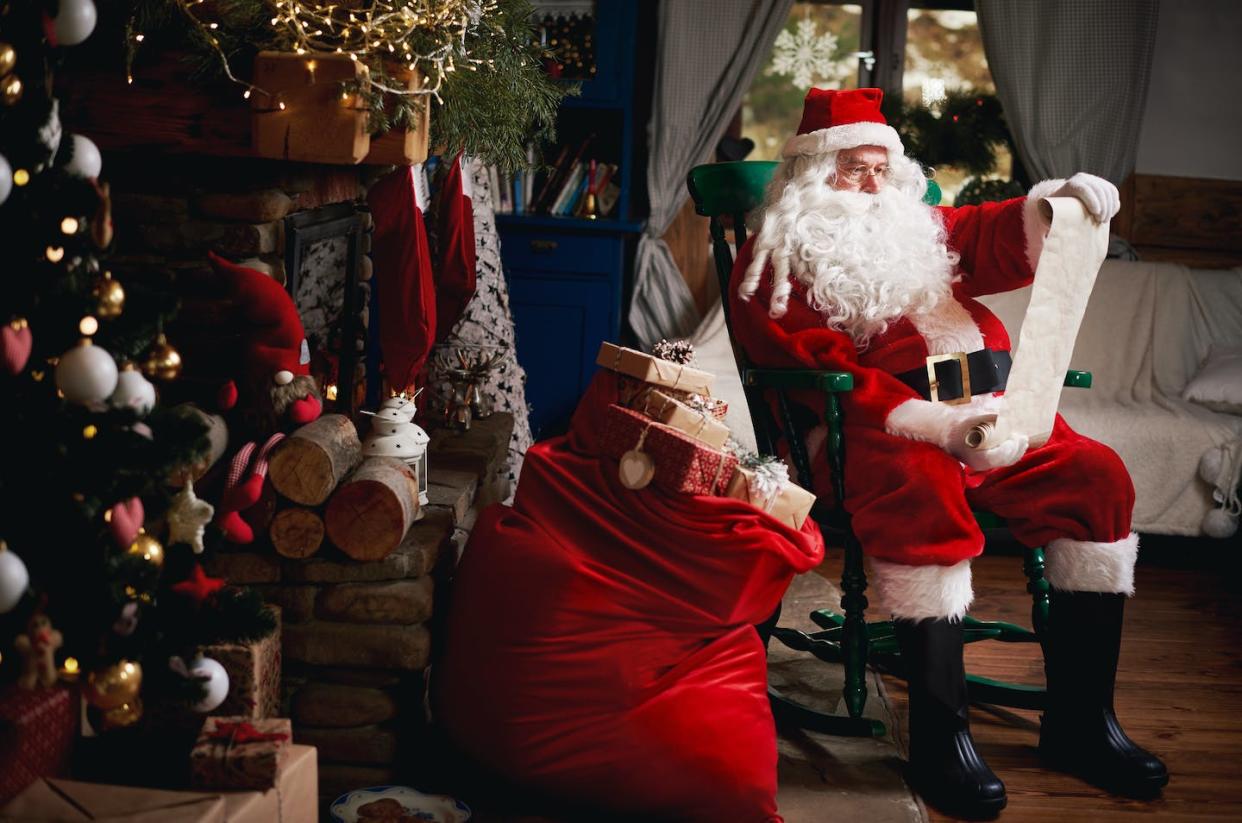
781 88 905 158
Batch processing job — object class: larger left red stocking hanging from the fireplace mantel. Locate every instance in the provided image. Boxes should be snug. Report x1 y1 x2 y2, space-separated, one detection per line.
366 164 436 390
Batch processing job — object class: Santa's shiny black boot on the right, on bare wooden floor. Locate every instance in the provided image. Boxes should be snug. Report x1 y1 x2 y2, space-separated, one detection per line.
1040 590 1169 798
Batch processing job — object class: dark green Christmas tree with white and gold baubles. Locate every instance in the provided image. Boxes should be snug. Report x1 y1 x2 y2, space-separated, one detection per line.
0 0 273 731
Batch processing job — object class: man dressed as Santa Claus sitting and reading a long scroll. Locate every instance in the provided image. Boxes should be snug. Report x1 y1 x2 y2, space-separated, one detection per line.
729 89 1169 816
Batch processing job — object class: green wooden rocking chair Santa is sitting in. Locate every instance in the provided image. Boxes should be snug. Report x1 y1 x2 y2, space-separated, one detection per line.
687 161 1090 736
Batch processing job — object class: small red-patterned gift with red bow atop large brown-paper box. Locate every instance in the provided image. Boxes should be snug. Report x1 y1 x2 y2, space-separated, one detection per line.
190 717 293 789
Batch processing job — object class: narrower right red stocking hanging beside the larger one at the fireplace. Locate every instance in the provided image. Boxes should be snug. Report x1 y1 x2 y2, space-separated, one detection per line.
436 151 474 343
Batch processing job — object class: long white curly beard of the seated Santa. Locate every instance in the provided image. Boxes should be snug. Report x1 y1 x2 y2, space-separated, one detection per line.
744 157 958 349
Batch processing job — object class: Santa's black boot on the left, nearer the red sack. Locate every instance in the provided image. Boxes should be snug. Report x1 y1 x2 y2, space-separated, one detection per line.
893 619 1005 819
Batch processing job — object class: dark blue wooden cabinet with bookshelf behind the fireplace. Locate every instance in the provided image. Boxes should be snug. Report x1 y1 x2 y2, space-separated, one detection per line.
496 0 653 439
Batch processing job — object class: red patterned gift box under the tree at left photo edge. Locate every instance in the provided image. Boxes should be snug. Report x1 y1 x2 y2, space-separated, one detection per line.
0 686 78 803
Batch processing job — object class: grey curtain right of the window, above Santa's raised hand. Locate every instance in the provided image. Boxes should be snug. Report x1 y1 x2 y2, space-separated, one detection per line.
975 0 1160 185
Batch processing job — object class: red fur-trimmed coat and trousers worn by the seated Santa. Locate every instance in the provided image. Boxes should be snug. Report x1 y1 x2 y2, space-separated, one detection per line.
729 192 1134 618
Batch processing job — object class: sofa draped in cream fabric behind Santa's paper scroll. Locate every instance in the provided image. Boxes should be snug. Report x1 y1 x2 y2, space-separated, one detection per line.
984 261 1242 535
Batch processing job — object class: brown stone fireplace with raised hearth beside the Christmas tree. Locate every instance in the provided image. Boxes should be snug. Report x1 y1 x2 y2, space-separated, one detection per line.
104 153 513 801
